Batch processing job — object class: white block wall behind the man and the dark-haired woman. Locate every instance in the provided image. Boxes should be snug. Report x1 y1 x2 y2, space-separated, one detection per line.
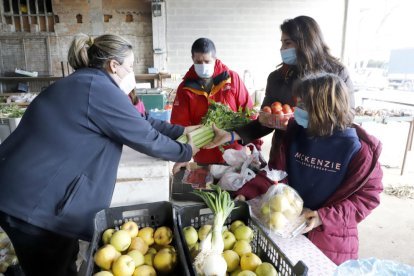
165 0 345 89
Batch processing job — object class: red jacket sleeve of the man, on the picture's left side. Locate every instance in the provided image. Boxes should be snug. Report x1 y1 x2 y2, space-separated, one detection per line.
170 83 191 126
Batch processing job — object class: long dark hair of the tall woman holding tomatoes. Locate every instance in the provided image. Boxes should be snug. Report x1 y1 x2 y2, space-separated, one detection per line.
280 15 344 76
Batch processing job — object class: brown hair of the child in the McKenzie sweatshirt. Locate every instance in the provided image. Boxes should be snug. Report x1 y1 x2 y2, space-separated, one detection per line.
293 72 354 136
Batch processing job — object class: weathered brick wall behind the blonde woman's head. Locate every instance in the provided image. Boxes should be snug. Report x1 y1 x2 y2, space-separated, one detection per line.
0 0 153 80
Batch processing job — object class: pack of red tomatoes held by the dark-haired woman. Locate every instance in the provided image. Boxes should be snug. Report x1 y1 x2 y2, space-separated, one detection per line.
259 101 295 129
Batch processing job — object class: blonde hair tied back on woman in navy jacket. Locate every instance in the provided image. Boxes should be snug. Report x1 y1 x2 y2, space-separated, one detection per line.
68 33 132 70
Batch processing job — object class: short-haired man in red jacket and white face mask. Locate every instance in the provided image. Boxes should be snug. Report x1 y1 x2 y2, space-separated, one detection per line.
171 38 261 172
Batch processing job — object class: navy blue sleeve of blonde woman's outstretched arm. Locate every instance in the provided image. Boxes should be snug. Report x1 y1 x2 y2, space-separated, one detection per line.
88 76 192 162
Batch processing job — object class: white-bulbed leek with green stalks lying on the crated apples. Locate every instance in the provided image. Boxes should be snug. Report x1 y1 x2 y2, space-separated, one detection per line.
194 185 235 276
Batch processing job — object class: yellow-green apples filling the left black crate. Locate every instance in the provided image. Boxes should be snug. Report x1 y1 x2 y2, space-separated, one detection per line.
94 221 177 276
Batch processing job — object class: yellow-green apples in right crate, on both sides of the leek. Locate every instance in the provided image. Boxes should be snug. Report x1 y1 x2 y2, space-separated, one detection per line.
183 220 278 276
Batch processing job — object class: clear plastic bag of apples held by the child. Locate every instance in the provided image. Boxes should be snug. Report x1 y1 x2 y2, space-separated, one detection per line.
260 184 303 231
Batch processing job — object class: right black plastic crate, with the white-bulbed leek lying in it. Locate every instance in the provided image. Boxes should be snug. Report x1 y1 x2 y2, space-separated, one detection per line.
174 201 308 276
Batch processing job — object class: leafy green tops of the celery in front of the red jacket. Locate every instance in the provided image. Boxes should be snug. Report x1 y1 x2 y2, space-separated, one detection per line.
201 100 255 130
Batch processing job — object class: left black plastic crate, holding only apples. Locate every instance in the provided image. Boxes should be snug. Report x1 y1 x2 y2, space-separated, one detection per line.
80 201 190 276
